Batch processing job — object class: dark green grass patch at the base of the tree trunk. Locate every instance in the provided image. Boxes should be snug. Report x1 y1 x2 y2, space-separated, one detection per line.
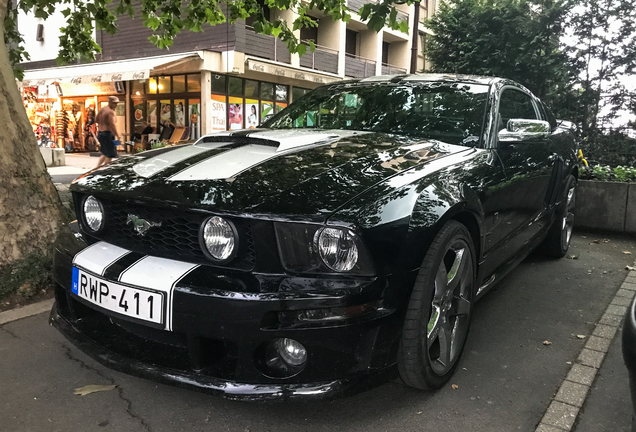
0 252 53 298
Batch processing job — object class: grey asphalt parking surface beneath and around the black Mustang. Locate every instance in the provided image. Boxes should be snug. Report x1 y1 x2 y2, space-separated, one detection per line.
0 234 636 432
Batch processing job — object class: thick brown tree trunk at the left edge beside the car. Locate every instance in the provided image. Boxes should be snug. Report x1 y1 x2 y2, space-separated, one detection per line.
0 0 63 268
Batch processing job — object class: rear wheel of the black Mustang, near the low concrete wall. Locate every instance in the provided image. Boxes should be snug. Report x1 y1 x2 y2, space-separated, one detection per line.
542 175 576 258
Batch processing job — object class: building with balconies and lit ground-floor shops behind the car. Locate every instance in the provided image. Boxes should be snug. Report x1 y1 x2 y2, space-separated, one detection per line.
19 0 437 149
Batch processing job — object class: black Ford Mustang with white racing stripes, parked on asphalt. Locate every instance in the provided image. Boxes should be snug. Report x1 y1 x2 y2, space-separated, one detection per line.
51 75 578 399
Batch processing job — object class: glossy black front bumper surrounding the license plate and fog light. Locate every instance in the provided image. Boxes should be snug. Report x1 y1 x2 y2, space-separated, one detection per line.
51 226 415 399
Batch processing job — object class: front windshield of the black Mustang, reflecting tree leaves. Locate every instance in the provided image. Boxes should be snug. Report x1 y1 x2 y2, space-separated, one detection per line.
263 82 488 146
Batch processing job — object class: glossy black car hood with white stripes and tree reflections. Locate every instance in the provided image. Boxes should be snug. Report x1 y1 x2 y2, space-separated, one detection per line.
71 129 467 220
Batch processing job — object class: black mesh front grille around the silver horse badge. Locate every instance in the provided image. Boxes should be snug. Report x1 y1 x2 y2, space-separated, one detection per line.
83 198 255 270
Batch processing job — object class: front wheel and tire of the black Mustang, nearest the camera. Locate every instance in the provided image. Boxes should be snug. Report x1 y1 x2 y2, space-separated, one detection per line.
398 220 475 390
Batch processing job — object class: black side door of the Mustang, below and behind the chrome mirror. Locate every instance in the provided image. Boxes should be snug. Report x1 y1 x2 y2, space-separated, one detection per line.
495 86 555 257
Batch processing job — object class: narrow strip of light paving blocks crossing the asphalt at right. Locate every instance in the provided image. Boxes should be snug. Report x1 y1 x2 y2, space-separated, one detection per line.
535 264 636 432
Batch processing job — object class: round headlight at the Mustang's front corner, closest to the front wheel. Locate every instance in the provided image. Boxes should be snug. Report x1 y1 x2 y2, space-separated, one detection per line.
315 228 358 272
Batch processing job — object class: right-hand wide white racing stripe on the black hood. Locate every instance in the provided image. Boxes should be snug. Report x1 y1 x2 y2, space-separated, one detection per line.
168 129 370 181
